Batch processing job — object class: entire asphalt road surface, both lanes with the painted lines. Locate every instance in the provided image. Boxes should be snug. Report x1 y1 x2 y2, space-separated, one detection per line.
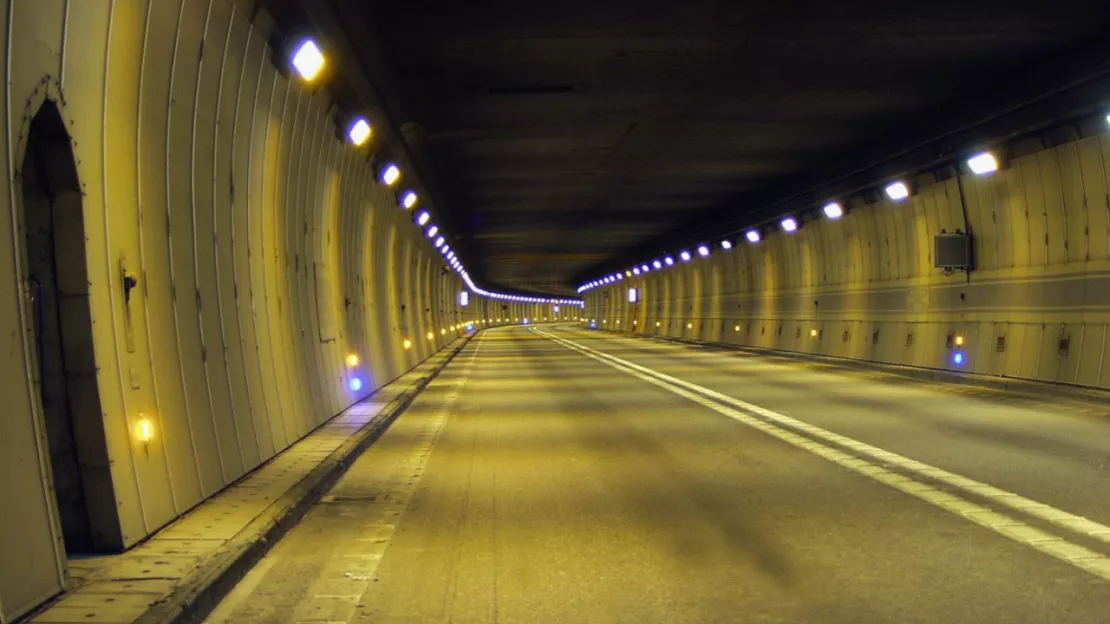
209 325 1110 623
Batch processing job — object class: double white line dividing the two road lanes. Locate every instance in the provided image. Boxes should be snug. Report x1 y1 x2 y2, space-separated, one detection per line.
531 328 1110 581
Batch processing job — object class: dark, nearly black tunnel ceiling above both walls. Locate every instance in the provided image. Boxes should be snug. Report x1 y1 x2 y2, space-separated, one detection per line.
305 0 1110 292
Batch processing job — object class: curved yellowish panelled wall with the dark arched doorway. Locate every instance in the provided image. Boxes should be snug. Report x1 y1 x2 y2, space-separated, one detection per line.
0 0 563 622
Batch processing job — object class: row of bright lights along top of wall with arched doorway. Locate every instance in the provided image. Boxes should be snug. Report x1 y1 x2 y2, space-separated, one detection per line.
290 39 585 306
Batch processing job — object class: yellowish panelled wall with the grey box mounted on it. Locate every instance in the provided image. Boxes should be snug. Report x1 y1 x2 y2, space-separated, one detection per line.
586 131 1110 388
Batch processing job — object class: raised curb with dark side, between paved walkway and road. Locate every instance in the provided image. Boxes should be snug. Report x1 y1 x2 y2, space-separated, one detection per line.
122 330 481 624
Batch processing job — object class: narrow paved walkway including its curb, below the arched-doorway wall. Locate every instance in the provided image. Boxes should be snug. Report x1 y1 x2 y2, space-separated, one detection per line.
28 334 474 624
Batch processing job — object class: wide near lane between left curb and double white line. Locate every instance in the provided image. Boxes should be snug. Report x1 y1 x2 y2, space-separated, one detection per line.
212 328 1110 622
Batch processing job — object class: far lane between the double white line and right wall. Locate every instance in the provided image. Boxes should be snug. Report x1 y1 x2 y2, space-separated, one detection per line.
555 326 1110 532
